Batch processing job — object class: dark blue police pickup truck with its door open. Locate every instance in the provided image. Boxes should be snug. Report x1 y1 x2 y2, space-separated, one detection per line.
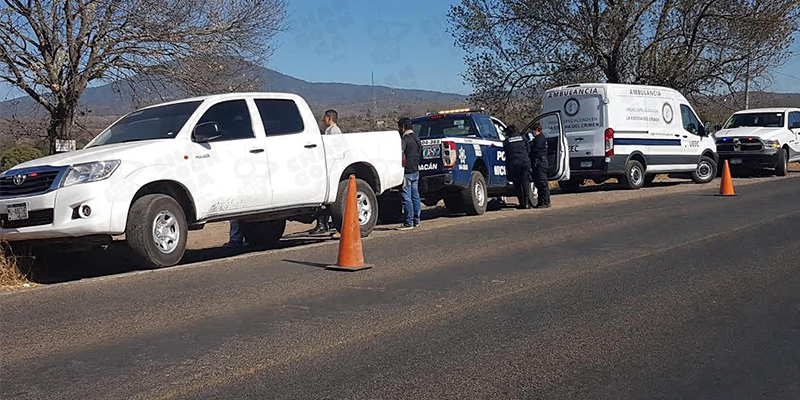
411 109 569 215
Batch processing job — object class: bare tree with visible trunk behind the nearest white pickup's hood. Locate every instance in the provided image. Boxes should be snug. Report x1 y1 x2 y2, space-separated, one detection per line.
0 0 286 151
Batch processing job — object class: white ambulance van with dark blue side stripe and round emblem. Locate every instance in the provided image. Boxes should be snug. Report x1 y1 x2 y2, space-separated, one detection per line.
542 83 718 192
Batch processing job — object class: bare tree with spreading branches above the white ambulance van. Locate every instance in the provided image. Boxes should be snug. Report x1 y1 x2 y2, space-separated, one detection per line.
449 0 800 117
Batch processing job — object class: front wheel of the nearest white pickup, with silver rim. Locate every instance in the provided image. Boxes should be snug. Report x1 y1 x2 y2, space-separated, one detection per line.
125 194 188 268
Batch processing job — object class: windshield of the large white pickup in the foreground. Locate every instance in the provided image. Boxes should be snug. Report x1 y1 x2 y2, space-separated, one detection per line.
87 101 202 147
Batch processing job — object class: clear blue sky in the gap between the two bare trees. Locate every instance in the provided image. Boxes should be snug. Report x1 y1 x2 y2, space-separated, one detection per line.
0 0 800 98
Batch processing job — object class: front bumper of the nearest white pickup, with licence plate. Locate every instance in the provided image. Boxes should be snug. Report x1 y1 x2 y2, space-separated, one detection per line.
0 180 120 242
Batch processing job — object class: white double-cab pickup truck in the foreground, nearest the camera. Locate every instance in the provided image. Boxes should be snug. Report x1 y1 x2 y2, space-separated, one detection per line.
0 93 403 266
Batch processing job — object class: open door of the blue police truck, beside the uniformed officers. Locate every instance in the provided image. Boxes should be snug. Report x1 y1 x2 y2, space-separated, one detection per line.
522 111 570 181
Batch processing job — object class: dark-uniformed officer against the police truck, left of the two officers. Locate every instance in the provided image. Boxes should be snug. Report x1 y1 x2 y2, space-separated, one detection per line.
503 125 531 210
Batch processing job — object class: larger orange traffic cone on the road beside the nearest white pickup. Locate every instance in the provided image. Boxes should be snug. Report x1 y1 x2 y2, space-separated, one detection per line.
326 175 372 272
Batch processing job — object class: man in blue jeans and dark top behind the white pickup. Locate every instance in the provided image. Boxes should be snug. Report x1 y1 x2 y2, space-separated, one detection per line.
397 118 422 231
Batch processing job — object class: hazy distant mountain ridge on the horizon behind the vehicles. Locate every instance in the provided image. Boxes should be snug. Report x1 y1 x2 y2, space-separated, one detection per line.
0 68 466 117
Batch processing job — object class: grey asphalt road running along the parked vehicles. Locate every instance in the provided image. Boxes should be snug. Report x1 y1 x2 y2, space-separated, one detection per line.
0 178 800 399
